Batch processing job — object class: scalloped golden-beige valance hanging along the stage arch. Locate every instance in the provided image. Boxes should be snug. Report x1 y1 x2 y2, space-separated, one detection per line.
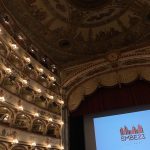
68 66 150 111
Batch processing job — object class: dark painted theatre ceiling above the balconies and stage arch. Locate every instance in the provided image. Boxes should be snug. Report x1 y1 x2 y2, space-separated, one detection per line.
1 0 150 70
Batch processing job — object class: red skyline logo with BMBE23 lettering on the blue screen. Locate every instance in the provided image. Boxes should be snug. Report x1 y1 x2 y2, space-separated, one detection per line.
120 124 145 142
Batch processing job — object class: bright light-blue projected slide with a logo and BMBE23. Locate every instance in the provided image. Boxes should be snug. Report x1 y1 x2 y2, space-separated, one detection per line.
94 110 150 150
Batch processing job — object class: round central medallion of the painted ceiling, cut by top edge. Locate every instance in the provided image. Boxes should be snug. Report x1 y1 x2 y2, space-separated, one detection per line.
45 0 135 27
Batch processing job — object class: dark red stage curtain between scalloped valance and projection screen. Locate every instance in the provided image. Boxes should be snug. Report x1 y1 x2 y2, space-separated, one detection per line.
71 80 150 116
